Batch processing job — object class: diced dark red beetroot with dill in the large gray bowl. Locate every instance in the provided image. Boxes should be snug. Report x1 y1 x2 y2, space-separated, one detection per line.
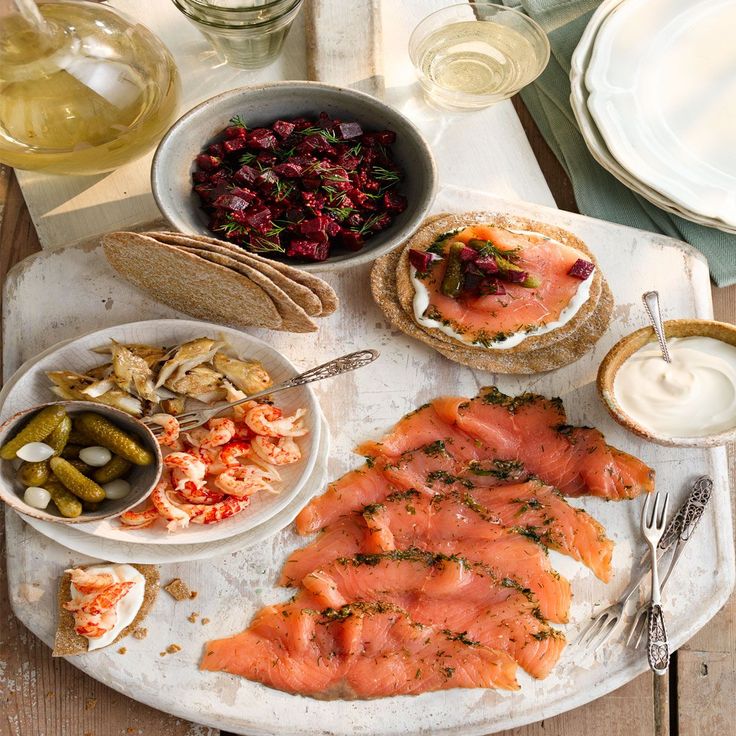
192 113 407 261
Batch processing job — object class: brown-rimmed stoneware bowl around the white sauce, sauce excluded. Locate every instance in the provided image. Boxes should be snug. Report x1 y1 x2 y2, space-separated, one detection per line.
596 319 736 447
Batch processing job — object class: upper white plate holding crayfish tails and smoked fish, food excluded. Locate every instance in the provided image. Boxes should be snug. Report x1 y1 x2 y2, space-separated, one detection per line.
0 319 326 546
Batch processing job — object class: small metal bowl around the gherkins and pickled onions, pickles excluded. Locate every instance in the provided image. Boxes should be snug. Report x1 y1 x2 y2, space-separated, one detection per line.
0 401 163 524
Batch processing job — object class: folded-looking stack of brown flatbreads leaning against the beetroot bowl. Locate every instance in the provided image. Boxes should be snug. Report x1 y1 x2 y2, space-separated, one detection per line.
102 232 338 332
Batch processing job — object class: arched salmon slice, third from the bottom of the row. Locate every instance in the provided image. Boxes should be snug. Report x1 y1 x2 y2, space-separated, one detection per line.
279 491 571 623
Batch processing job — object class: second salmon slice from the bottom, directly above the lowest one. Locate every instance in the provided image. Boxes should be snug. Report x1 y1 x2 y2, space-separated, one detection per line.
302 549 565 678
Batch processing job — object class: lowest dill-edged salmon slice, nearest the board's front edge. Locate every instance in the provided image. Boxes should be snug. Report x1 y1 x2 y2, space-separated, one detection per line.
200 602 519 699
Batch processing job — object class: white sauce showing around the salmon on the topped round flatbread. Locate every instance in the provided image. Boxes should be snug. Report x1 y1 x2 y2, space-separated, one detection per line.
410 230 595 350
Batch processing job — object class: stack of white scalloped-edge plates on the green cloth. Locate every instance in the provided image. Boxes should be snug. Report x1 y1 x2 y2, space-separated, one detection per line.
570 0 736 233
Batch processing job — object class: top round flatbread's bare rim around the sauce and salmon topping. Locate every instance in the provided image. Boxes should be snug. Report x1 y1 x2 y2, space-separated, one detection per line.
396 212 603 354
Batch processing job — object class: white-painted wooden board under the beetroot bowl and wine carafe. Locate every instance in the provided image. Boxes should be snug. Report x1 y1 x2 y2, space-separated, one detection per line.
17 0 554 249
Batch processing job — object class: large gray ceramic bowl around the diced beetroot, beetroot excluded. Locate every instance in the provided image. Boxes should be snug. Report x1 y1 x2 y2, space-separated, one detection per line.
151 82 437 271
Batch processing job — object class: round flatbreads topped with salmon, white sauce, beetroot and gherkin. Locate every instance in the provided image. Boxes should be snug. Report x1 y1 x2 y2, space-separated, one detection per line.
371 212 613 373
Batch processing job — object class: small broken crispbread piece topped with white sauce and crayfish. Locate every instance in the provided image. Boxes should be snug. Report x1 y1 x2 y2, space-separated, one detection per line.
53 563 159 657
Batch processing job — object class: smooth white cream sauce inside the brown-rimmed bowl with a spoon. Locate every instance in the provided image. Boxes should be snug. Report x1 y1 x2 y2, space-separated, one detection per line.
613 337 736 437
